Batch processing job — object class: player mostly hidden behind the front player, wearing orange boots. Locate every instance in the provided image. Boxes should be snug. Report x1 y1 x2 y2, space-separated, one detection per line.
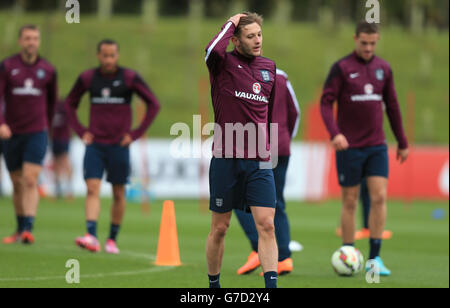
235 69 300 275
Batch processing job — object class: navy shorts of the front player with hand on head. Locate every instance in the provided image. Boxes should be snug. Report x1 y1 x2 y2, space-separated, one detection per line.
209 158 277 213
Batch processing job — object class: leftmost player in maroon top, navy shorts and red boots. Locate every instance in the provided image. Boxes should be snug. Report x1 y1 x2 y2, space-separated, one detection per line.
0 25 58 244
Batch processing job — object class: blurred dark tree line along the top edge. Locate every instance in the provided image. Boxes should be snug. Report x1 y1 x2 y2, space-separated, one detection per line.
0 0 449 30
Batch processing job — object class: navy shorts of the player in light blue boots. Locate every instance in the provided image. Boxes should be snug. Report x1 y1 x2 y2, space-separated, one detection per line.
336 145 389 187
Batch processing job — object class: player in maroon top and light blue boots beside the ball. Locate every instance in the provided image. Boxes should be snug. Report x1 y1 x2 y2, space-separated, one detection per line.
321 22 409 276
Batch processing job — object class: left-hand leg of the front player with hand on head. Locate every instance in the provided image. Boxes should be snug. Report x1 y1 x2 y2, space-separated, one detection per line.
206 211 232 288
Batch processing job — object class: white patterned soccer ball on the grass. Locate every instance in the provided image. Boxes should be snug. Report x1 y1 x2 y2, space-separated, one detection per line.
331 246 364 276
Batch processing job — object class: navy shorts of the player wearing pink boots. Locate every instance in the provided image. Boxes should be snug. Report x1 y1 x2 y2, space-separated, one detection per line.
84 143 131 185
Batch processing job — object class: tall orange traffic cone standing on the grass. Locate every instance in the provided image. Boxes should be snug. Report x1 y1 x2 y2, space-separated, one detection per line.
155 201 181 266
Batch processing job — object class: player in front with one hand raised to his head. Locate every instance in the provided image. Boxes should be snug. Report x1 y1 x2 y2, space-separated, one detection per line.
205 13 278 288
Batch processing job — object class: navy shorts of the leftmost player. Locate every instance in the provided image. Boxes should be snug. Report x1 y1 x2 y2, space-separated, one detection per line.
3 131 48 172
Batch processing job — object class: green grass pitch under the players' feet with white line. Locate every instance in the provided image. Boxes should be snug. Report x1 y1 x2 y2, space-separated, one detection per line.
0 198 449 288
